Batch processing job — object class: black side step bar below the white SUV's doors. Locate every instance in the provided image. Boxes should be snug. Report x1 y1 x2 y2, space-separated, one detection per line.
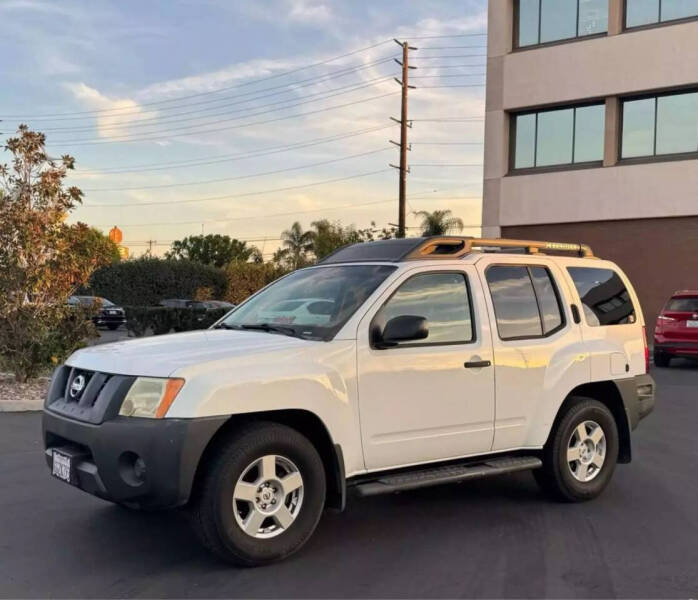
354 456 543 496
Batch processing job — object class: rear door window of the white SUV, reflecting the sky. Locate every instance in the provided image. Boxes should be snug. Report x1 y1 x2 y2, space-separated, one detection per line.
485 265 565 340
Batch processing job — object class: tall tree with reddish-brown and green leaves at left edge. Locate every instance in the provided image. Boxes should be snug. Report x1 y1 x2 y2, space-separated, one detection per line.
0 125 113 381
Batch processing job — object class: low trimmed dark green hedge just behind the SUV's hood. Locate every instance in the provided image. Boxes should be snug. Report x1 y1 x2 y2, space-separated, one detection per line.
124 306 228 337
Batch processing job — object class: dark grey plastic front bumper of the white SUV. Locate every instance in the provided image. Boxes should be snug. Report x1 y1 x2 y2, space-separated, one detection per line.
42 410 228 508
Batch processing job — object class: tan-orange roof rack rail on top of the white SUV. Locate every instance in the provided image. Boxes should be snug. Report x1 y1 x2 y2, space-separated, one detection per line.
403 236 595 260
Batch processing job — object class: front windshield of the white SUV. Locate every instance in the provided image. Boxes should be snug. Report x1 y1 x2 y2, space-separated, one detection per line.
218 265 395 341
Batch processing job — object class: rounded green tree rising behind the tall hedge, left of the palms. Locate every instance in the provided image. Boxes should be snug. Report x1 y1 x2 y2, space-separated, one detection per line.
165 234 260 268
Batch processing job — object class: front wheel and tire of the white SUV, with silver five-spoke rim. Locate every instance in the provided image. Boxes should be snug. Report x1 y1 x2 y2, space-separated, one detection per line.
186 422 326 567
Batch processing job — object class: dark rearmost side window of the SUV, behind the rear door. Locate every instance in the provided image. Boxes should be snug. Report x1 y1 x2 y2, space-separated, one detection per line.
567 267 636 327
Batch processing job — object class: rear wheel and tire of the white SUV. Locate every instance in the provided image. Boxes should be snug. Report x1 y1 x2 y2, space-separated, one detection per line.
533 397 618 502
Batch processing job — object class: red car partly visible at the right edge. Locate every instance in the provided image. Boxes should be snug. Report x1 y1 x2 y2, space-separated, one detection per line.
654 290 698 367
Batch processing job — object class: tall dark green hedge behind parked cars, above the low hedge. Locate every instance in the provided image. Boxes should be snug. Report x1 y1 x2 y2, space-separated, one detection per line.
89 257 226 307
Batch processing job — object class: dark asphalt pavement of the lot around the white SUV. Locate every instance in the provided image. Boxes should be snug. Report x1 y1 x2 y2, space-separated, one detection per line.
0 363 698 598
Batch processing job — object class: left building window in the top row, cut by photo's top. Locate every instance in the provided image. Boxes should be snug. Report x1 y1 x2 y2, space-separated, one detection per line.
516 0 608 48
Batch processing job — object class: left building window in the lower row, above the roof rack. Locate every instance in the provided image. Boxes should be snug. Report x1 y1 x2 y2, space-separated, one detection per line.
512 104 606 170
